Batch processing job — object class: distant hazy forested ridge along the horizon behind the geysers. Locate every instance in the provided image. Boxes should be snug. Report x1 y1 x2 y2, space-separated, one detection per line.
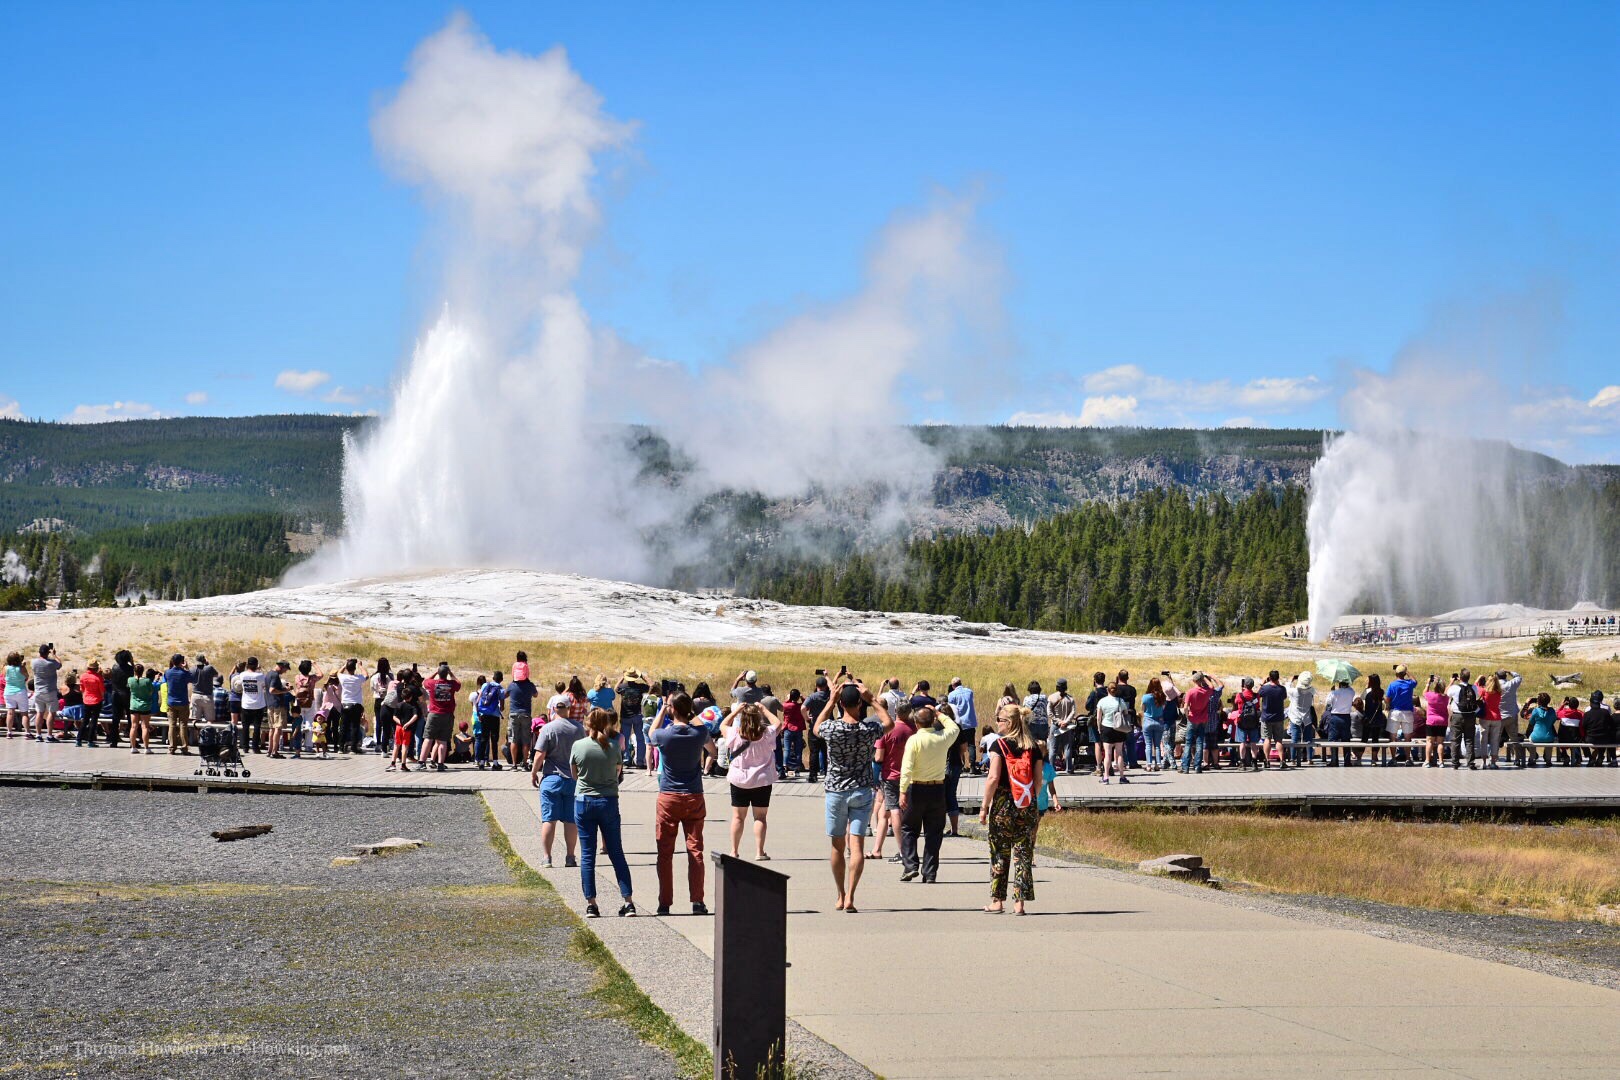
0 415 1594 533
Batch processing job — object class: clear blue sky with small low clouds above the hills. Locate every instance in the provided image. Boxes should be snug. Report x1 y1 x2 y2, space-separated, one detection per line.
9 2 1620 460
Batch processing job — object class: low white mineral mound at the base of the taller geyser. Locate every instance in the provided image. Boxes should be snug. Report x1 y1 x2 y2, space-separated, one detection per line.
164 570 1276 656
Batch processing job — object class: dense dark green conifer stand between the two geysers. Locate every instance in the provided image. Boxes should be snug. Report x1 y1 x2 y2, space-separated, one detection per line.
737 487 1309 635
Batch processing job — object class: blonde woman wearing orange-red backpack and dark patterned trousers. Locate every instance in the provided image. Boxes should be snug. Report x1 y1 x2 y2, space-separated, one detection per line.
978 704 1045 915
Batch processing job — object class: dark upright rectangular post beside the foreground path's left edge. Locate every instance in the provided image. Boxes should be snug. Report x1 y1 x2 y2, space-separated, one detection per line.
714 852 787 1080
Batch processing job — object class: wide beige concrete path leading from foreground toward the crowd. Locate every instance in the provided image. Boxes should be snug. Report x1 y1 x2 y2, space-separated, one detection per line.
489 790 1620 1080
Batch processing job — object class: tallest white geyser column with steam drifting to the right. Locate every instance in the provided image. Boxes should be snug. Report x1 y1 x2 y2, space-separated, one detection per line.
293 16 1001 580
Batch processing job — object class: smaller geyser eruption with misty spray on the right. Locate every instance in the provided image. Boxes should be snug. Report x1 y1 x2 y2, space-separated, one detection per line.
1306 296 1605 641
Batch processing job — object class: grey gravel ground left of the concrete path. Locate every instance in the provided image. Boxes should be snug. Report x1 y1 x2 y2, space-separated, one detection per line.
0 789 677 1078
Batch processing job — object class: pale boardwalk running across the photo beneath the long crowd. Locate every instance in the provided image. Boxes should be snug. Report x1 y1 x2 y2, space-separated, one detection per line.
0 738 1620 811
